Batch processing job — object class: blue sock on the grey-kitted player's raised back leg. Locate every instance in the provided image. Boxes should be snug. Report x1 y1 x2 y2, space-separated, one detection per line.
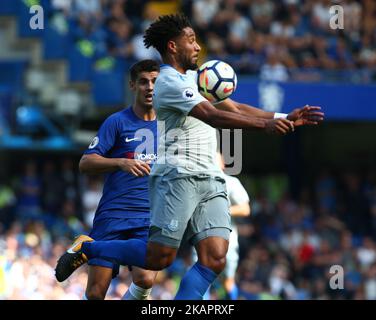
82 239 147 268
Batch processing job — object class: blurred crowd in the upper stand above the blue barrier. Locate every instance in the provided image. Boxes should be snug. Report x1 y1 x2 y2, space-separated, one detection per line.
45 0 376 82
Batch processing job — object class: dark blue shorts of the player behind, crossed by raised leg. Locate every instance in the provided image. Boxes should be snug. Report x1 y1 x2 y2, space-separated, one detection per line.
88 218 150 278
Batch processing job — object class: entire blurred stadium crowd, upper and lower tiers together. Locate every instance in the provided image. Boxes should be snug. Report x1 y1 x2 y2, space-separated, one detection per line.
0 0 376 300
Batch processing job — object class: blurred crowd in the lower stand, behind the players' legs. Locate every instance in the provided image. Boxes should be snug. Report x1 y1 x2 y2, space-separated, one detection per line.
0 157 376 300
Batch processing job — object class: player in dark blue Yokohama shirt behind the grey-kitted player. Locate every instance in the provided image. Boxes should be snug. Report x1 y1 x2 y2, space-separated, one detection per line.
69 60 159 300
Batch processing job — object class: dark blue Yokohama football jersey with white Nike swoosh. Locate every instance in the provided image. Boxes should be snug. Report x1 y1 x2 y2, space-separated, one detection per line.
85 107 158 220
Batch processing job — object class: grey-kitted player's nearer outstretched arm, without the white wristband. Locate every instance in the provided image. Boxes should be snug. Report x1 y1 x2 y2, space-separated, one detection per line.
189 101 294 134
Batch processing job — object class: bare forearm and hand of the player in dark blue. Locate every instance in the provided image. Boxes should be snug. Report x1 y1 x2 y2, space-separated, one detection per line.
79 153 150 177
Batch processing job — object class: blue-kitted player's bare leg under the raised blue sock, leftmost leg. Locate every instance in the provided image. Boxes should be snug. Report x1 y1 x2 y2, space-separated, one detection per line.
86 265 113 299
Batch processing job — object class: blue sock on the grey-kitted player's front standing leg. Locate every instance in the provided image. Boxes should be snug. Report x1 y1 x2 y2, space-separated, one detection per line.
175 262 217 300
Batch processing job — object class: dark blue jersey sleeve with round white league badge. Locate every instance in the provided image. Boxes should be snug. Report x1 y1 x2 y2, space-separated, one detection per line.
84 115 119 156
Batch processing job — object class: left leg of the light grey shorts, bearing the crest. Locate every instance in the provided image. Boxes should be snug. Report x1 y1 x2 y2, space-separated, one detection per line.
149 175 200 249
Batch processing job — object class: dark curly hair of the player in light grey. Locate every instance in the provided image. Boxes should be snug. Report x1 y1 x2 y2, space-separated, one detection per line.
144 14 192 56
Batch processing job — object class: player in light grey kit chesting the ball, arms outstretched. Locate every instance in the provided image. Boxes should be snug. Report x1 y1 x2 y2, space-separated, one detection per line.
56 15 323 300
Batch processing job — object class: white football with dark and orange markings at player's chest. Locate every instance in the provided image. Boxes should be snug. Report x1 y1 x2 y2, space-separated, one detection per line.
197 60 237 102
